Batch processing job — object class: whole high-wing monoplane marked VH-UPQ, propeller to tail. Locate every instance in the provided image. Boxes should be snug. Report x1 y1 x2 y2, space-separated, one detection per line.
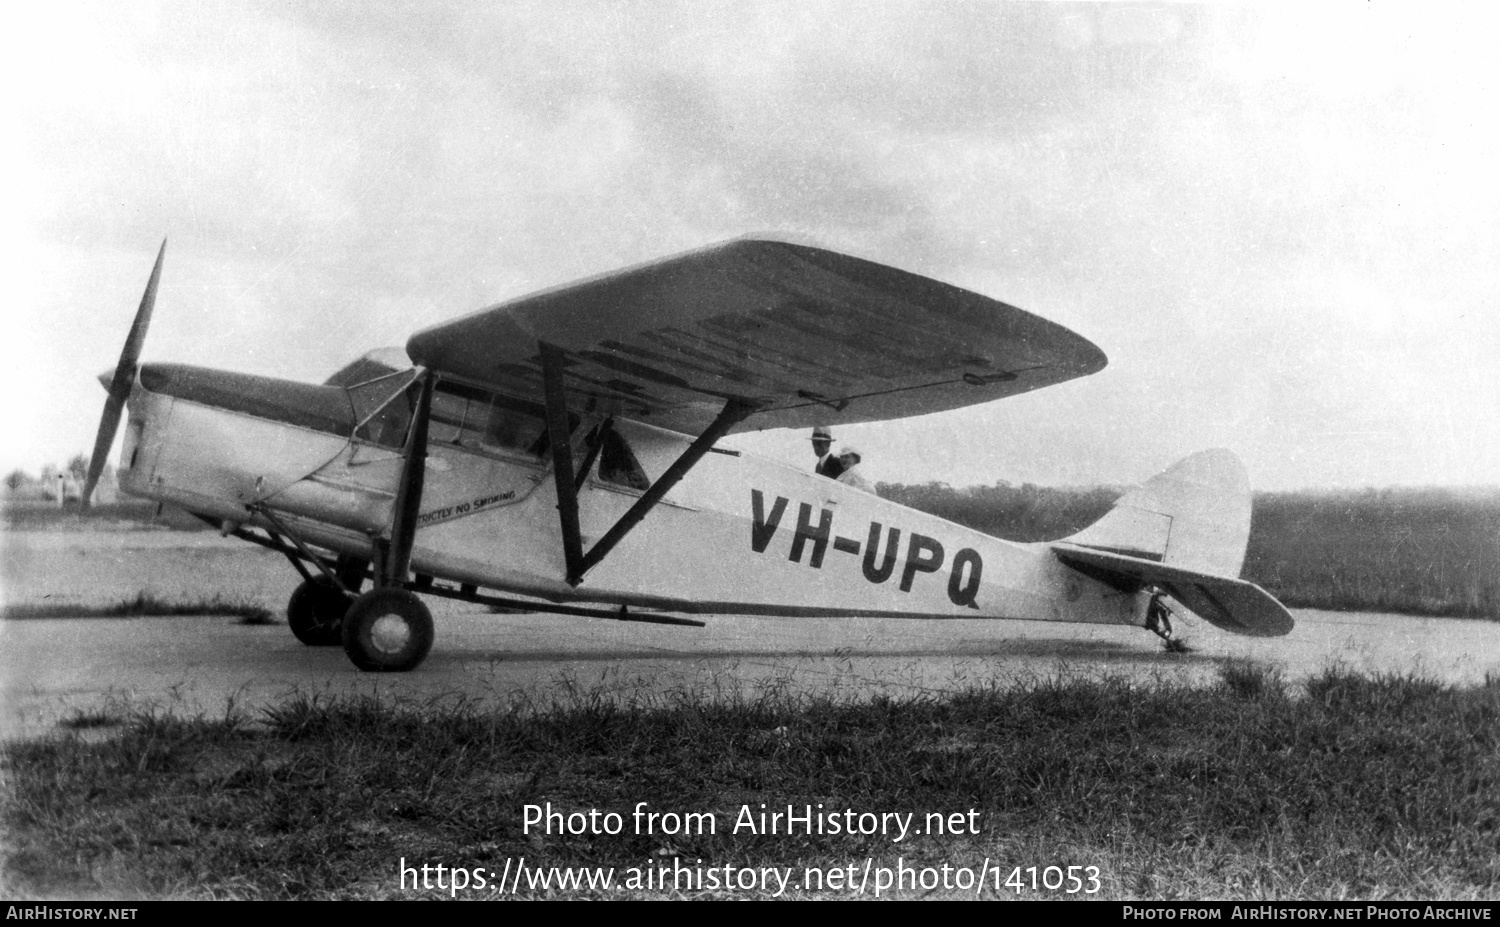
84 240 1292 671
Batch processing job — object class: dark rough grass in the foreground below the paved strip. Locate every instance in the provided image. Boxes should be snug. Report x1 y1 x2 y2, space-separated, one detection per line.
0 665 1500 900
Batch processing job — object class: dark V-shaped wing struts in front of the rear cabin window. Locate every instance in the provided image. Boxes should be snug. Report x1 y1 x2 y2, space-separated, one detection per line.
542 342 759 587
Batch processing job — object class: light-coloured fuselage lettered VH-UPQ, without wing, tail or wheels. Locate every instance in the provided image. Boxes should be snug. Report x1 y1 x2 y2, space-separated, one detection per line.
120 365 1146 626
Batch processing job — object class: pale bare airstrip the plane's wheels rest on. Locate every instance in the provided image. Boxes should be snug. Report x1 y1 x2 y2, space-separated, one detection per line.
0 530 1500 737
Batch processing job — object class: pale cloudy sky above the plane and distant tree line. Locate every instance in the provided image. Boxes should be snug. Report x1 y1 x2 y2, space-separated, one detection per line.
11 0 1500 489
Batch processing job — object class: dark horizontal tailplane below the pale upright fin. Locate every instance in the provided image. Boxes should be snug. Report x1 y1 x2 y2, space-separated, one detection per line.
1052 543 1295 638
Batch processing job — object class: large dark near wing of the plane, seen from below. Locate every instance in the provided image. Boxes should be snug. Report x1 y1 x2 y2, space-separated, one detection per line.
407 240 1106 434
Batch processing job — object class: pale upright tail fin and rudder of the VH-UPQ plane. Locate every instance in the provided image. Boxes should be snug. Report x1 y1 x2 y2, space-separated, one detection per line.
1064 450 1250 578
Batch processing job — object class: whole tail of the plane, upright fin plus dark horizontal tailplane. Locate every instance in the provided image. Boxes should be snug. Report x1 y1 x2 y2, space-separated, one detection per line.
1053 450 1293 636
